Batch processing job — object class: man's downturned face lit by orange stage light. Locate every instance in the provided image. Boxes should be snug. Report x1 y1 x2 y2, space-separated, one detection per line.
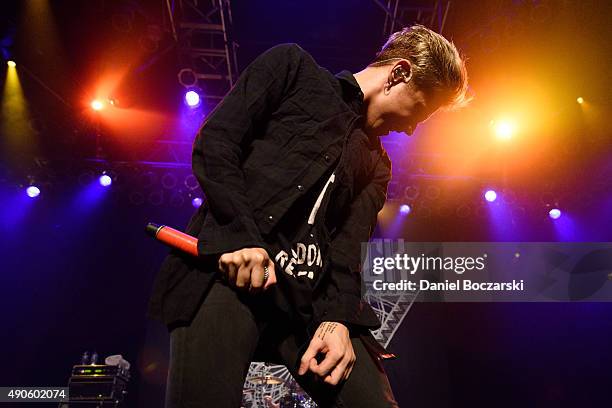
366 73 440 136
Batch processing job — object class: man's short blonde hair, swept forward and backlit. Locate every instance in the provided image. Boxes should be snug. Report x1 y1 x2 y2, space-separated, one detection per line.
370 25 471 108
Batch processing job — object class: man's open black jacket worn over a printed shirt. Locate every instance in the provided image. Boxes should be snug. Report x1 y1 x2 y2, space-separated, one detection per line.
149 44 391 355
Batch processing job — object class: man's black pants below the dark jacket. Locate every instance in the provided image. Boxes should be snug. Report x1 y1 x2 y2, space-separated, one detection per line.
166 280 397 408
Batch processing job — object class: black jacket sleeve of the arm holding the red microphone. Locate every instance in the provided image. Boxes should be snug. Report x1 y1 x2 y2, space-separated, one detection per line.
192 44 301 256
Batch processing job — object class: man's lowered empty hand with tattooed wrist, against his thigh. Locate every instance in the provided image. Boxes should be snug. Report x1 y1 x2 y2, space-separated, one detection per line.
298 322 355 385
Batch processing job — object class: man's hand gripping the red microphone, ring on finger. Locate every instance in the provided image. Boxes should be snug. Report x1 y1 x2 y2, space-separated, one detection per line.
219 248 276 294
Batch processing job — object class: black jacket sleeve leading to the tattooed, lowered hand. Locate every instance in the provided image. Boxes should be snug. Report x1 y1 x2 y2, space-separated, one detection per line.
317 151 391 329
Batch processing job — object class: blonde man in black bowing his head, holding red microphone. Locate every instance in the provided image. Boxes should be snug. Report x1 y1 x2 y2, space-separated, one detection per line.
149 26 467 408
